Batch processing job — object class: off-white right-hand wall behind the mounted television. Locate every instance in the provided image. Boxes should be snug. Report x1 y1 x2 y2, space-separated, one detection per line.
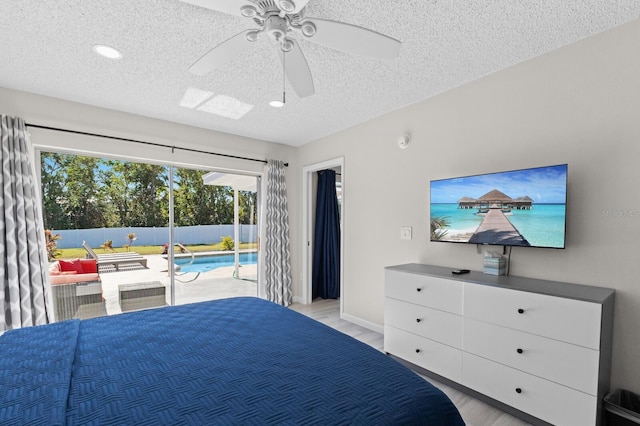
298 21 640 392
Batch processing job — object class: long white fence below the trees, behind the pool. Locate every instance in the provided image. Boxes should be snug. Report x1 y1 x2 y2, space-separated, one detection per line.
52 225 258 248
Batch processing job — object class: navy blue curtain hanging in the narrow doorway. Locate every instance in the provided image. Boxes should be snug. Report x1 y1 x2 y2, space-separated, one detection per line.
312 170 340 299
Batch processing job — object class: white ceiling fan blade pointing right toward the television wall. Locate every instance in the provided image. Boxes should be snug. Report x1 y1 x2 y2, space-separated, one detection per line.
307 18 402 59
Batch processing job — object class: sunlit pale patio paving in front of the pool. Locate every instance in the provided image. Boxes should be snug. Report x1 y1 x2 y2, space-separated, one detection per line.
100 255 257 315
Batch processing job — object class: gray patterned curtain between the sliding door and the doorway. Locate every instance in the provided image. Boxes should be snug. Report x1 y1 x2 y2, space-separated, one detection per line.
265 160 292 306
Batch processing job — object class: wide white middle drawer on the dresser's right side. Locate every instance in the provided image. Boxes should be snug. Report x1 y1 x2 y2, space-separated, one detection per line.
464 318 600 395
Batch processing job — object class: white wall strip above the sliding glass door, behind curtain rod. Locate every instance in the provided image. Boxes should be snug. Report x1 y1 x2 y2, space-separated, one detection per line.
0 87 295 173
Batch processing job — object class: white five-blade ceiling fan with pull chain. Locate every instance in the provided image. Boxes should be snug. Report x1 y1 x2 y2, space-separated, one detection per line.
180 0 401 98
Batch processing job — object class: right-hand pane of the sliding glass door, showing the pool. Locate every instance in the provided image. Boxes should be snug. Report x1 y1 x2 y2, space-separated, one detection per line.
174 168 258 304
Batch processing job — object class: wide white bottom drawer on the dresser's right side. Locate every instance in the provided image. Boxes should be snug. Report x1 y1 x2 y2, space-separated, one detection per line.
462 353 597 426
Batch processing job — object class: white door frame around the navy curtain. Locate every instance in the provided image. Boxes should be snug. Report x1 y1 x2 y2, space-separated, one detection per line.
300 157 345 315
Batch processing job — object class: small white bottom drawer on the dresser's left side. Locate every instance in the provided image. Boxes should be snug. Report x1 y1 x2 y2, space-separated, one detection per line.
384 325 462 383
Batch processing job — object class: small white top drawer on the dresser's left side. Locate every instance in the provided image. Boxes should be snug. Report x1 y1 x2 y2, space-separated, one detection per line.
385 270 463 315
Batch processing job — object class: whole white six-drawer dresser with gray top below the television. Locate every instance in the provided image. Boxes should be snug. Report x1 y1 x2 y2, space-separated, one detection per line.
384 264 615 426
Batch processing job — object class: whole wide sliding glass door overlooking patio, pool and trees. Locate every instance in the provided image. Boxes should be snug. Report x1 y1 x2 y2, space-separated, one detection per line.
40 152 259 315
